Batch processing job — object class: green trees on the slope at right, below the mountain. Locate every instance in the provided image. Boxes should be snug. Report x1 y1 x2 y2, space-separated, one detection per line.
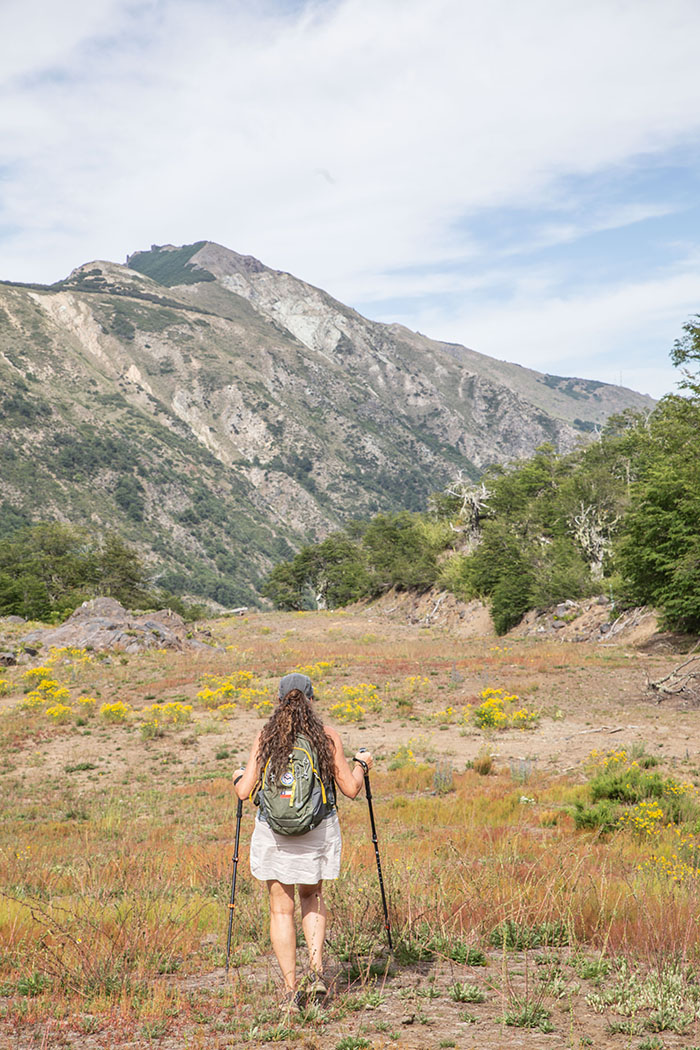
263 322 700 633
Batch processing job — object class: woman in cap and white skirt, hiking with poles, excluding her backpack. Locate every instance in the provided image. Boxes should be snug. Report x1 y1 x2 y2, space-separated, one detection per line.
233 673 373 1003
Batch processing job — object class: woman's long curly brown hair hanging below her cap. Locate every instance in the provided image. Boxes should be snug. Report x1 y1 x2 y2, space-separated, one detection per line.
257 689 335 784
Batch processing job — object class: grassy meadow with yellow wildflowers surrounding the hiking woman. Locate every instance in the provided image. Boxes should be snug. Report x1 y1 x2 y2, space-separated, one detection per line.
0 612 700 1050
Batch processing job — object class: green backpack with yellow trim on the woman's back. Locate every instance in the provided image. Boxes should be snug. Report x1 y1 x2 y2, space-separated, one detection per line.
256 735 336 835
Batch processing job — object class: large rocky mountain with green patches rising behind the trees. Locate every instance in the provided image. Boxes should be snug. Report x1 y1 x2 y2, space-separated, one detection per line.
0 242 654 605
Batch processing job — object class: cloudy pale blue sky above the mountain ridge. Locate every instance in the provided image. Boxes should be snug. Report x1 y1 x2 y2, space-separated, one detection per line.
0 0 700 397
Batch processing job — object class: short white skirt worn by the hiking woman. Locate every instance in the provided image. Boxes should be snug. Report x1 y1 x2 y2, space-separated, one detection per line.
251 813 342 886
